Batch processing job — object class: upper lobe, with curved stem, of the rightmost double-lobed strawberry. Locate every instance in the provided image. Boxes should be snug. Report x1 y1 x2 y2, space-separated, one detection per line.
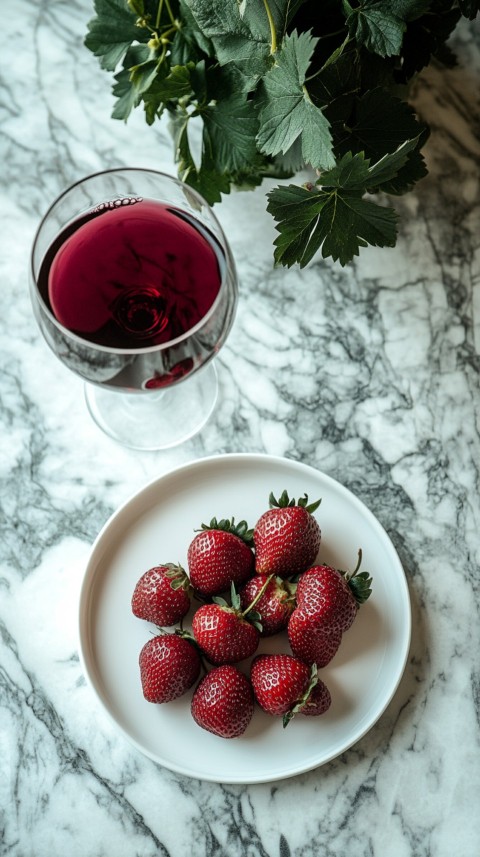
297 551 372 633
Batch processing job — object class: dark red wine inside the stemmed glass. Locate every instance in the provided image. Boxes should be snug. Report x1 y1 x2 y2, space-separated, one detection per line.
38 197 222 349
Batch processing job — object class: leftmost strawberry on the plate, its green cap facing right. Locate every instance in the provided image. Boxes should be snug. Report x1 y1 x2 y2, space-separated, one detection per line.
132 563 192 627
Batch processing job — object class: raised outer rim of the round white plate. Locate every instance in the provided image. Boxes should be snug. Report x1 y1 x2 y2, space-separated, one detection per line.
77 452 412 785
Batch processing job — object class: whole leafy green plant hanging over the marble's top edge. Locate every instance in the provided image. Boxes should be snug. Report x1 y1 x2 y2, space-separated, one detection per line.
85 0 480 267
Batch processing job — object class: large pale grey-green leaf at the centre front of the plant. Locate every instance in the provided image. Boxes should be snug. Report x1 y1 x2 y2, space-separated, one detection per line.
257 32 334 168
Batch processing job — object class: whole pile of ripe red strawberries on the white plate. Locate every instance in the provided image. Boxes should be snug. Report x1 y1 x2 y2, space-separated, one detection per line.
132 491 372 738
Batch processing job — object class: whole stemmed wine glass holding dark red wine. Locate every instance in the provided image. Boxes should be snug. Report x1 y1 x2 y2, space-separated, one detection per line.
30 168 238 449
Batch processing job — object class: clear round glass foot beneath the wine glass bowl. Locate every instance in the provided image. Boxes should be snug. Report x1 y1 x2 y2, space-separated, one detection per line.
85 363 218 450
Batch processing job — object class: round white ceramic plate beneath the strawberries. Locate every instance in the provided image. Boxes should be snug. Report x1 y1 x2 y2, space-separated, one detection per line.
80 454 411 783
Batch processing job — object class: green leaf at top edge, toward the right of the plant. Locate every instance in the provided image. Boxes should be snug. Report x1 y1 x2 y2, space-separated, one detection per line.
343 0 406 57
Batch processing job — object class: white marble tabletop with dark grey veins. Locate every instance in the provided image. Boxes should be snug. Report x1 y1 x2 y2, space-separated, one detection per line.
0 0 480 857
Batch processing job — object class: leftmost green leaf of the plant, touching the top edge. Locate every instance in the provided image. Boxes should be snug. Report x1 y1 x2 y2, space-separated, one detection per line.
85 0 144 71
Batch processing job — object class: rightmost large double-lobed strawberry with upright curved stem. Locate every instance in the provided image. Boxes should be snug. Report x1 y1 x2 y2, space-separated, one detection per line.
288 551 372 667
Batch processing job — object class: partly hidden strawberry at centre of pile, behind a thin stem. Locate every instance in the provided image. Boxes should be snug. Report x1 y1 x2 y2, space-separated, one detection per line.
240 574 296 637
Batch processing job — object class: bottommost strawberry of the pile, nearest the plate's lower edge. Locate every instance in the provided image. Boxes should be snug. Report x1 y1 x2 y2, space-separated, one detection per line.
191 664 253 738
